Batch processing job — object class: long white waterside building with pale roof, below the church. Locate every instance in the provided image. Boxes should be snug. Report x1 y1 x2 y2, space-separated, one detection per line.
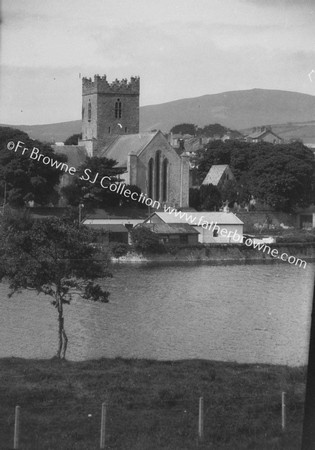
145 211 244 244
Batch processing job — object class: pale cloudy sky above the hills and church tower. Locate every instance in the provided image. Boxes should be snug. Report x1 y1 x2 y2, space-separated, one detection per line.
0 0 315 125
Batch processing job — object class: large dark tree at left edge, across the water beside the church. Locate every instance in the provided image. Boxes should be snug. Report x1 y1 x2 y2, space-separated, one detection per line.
0 127 67 206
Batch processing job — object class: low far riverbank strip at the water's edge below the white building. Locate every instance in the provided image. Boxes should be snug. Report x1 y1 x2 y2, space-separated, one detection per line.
111 242 315 267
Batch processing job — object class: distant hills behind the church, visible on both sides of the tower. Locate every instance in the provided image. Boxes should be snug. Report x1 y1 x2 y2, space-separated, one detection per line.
3 89 315 142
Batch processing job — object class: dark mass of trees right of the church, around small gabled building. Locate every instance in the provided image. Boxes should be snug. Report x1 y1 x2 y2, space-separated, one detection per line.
197 141 315 211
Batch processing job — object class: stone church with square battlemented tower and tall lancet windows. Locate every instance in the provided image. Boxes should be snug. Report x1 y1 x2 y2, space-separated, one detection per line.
54 75 189 207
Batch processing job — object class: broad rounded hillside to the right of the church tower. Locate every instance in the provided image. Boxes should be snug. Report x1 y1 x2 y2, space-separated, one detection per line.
140 89 315 131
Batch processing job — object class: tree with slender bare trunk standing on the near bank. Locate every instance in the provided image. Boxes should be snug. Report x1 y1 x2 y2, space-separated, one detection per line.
0 215 111 359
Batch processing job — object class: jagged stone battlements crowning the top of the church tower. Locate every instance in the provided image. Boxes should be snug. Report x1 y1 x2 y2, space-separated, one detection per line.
82 75 140 95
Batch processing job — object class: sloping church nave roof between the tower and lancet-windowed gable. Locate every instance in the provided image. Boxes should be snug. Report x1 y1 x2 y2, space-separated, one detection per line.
99 131 160 167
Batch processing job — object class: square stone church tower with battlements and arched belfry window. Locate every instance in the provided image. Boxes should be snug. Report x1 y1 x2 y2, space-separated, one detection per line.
79 75 140 156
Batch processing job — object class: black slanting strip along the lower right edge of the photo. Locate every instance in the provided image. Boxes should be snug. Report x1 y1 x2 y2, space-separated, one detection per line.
302 279 315 450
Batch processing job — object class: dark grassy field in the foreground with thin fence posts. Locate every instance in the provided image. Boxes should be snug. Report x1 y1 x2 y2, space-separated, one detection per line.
0 358 306 450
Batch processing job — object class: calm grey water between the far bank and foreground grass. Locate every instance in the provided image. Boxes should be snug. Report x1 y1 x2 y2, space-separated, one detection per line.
0 264 315 365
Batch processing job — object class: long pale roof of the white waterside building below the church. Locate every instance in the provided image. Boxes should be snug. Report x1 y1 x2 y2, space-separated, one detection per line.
151 211 243 226
